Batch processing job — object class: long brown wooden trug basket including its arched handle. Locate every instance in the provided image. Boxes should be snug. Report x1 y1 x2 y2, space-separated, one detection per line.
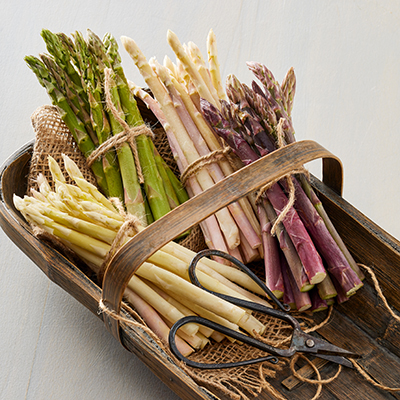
0 104 400 400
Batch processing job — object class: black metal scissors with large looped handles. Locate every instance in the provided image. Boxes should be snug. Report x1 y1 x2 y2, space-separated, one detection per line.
168 249 361 369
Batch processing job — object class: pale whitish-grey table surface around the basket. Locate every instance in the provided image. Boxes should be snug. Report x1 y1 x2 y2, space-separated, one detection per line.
0 0 400 400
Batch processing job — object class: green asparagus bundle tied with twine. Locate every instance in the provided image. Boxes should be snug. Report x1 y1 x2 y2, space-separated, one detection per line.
25 30 188 226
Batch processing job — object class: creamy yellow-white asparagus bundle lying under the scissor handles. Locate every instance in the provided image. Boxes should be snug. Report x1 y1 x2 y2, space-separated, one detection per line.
14 156 269 355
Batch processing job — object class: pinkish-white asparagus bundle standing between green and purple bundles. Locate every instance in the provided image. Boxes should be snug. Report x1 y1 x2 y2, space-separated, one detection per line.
121 31 262 263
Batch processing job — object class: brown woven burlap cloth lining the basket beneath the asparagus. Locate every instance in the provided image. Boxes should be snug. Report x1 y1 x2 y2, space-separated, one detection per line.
28 105 398 399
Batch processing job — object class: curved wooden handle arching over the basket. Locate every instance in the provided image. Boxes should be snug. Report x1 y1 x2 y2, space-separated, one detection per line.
102 140 343 341
